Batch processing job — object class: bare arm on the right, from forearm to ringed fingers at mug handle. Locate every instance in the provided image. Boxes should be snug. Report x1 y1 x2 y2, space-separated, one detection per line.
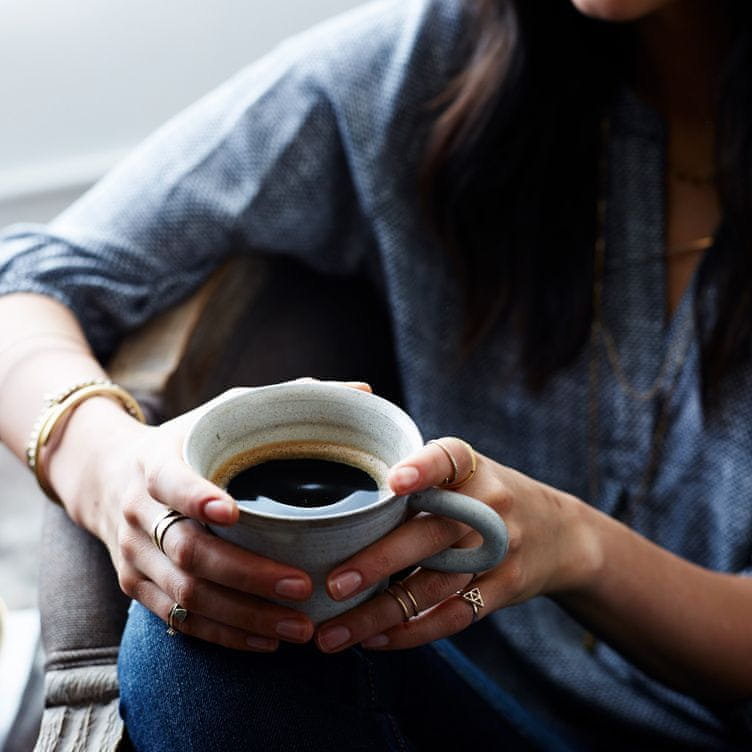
317 439 752 700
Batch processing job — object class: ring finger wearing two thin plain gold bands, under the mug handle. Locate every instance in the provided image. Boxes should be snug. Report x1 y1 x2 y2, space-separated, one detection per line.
316 569 469 653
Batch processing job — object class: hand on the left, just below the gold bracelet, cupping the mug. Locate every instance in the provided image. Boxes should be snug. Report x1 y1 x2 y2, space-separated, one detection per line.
48 398 314 652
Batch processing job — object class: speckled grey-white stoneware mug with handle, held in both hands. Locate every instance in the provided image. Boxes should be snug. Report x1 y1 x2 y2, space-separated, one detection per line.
184 381 507 623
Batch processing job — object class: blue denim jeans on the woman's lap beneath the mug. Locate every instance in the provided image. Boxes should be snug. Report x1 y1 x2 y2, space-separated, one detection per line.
119 604 567 752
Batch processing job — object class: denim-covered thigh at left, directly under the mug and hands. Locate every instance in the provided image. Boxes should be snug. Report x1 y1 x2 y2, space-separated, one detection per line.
119 604 409 752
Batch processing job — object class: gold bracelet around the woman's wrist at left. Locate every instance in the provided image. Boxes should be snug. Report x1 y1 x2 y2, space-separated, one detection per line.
26 379 145 504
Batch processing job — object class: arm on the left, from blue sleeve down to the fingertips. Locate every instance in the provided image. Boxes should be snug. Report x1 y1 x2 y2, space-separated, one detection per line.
0 1 418 650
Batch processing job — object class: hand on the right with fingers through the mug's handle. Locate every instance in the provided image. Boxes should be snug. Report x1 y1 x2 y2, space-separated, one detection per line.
316 437 601 652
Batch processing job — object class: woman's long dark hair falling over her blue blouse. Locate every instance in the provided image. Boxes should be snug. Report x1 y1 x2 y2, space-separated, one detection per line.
421 0 752 404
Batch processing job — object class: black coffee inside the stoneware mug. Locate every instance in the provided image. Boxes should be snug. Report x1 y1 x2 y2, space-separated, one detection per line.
227 459 379 508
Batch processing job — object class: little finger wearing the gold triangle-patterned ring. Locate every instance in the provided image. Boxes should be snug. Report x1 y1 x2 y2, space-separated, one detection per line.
361 577 493 650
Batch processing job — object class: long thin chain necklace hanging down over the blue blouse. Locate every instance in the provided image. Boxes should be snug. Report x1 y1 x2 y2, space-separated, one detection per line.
588 129 712 504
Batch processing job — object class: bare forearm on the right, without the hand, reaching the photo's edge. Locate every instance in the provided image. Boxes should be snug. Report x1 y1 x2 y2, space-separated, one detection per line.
556 505 752 699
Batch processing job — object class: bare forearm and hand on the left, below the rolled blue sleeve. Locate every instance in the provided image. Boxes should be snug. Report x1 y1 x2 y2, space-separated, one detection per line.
0 295 312 651
